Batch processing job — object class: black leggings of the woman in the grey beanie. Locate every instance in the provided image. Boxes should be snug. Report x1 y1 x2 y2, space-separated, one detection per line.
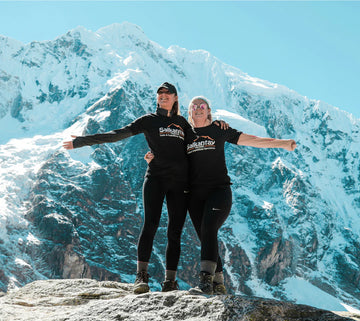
189 186 232 272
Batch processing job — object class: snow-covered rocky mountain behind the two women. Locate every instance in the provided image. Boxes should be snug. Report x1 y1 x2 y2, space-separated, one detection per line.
0 23 360 310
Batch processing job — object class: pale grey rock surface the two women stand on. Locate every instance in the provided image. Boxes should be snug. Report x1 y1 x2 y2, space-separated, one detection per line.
0 279 360 321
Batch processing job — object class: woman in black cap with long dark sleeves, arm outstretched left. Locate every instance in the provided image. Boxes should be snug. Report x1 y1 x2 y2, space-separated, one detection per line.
63 82 195 293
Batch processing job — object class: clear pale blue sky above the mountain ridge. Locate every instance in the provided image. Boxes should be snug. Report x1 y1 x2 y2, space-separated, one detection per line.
0 1 360 118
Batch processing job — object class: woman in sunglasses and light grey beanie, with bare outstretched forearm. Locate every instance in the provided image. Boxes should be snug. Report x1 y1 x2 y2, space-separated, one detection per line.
145 96 296 294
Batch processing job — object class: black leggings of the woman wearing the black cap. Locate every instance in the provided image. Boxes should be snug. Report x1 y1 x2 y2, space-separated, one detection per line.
138 177 188 271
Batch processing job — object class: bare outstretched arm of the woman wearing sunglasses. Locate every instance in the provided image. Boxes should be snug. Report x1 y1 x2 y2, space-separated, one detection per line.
237 133 296 151
